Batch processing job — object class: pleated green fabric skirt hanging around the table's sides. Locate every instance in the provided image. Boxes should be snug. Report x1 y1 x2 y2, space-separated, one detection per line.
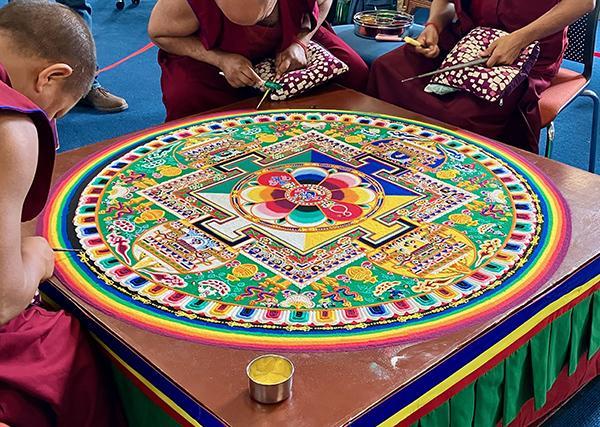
113 291 600 427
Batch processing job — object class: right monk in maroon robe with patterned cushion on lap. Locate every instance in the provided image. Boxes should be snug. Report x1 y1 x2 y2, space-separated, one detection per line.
368 0 594 152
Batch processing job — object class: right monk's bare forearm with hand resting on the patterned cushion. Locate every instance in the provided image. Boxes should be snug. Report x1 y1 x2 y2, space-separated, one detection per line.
481 0 595 67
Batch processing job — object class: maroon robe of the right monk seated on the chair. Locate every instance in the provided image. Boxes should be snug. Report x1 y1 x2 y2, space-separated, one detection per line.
368 0 566 152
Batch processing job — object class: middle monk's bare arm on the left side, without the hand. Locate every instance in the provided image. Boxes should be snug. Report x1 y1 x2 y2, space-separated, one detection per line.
148 0 222 67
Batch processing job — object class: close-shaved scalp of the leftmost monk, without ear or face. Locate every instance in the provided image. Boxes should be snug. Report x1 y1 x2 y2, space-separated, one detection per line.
0 0 96 96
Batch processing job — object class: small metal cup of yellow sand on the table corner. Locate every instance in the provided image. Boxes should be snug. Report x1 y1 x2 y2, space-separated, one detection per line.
246 354 294 404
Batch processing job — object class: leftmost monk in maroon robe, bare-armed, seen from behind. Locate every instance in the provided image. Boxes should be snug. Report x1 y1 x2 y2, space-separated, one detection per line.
0 1 121 427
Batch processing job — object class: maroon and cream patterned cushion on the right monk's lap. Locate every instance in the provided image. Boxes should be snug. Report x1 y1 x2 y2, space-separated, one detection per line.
425 27 540 102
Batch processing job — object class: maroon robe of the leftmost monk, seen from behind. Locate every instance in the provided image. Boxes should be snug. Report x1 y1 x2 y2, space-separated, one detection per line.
0 65 122 427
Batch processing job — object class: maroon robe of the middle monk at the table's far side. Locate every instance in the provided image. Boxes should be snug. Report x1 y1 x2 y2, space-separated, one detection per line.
158 0 368 120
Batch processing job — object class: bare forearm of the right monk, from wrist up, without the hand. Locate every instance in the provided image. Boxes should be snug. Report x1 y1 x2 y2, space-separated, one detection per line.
516 0 595 46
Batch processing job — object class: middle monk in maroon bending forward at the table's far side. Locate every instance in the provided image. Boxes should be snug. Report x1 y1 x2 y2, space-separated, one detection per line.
148 0 368 120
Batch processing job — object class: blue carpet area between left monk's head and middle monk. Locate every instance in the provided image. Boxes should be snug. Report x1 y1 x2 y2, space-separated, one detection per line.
58 0 165 150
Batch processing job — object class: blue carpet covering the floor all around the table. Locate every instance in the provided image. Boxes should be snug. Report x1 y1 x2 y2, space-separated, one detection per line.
15 0 600 427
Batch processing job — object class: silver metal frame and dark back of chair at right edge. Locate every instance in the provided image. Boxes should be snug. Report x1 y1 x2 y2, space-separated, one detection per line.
544 1 600 173
